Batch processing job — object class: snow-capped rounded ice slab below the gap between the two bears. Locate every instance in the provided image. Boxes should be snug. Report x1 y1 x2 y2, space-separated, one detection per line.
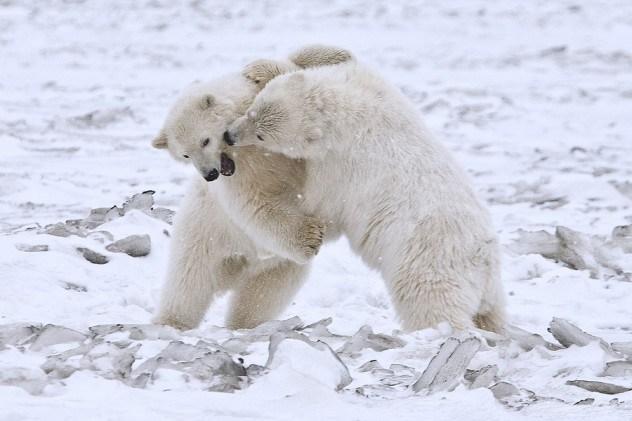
265 332 352 390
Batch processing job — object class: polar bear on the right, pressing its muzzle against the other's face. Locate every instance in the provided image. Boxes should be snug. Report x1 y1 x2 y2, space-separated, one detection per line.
226 62 505 332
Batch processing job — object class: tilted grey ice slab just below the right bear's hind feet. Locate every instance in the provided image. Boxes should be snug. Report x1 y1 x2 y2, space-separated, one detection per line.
412 337 481 392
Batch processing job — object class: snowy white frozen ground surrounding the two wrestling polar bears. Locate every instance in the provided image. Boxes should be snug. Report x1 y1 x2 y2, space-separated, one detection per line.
0 0 632 421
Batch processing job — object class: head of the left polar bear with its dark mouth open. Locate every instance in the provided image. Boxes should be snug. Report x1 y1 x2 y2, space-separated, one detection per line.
152 83 238 181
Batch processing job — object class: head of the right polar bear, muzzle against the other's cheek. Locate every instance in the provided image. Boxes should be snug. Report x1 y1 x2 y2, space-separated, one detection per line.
224 72 324 158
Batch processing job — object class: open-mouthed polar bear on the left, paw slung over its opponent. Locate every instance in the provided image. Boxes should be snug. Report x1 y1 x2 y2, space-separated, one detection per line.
152 46 351 329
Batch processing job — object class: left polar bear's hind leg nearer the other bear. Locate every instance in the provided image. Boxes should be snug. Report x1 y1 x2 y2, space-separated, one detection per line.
226 259 309 329
